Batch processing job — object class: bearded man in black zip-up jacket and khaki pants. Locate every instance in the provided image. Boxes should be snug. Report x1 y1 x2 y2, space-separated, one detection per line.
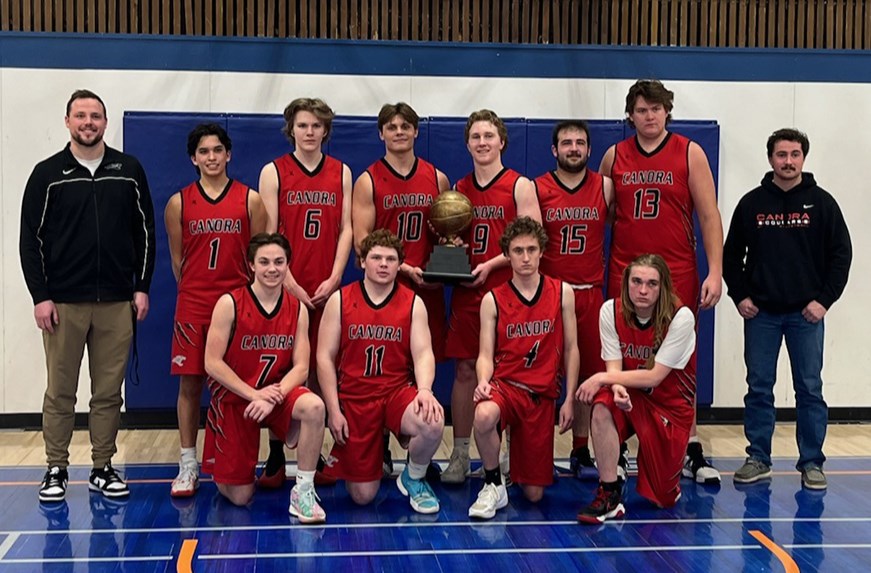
19 90 155 502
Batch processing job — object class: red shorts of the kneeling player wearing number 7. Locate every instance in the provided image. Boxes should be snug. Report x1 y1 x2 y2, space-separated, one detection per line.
203 386 309 485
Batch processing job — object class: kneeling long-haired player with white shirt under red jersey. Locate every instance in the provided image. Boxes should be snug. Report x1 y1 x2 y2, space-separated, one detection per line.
578 255 696 524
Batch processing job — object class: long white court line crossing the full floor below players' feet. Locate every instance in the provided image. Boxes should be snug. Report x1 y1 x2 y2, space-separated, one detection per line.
0 517 871 535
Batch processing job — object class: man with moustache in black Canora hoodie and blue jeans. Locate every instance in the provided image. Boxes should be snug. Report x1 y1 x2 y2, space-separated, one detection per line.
723 129 853 489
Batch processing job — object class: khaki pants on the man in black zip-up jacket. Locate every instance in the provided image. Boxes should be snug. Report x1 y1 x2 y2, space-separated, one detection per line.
42 302 134 468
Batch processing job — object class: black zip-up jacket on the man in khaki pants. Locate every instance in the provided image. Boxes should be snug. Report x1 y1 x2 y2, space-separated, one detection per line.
19 144 155 305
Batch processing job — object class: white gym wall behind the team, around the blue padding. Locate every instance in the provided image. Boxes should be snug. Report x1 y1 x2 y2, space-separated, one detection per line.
0 68 871 413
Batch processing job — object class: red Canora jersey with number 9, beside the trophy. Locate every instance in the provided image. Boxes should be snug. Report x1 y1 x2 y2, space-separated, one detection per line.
454 167 520 290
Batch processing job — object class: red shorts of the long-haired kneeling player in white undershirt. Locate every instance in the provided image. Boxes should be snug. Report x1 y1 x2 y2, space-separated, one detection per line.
593 386 692 507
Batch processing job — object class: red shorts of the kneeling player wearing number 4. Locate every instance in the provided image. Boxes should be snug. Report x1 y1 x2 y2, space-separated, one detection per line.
490 380 556 486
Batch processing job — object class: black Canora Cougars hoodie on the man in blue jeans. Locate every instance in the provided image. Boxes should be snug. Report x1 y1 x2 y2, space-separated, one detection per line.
723 172 853 313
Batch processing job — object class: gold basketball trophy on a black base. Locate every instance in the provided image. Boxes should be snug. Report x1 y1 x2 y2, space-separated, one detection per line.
423 191 475 284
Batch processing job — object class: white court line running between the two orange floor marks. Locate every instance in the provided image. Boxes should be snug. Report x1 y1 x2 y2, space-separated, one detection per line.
197 545 764 561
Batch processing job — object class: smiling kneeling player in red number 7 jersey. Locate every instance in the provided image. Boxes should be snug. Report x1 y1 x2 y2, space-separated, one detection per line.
203 233 326 523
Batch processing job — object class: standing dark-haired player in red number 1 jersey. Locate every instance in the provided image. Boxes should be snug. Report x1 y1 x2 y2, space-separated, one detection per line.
164 123 266 497
